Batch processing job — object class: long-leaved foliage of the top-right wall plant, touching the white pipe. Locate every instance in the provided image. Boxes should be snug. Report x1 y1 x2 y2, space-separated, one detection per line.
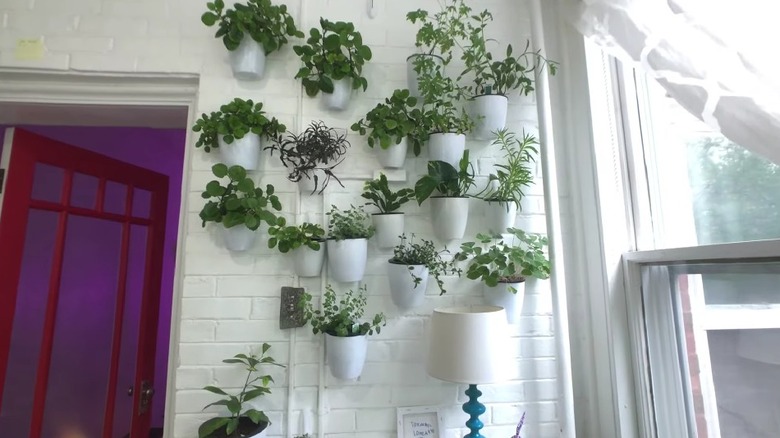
458 10 558 96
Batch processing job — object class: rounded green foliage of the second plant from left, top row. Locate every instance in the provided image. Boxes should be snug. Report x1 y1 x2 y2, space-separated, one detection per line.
293 18 372 97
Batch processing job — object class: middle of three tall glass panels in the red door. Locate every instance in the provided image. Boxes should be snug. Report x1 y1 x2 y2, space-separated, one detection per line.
42 215 122 437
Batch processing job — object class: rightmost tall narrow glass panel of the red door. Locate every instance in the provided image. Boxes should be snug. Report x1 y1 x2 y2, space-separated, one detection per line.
113 225 147 438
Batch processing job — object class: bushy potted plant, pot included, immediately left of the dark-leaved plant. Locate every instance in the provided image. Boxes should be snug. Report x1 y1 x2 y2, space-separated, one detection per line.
192 97 287 170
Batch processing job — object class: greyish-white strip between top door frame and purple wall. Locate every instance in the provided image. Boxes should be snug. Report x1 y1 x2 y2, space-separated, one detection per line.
0 102 187 129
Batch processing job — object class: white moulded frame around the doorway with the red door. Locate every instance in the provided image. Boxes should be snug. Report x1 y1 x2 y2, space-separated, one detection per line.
0 69 199 436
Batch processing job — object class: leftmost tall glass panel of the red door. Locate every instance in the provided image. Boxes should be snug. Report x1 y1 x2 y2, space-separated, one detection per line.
0 210 58 437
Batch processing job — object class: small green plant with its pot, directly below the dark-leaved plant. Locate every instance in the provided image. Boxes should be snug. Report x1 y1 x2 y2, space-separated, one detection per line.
268 217 325 277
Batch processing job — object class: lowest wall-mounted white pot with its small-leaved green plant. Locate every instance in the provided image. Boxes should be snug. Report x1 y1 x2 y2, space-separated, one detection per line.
299 285 387 380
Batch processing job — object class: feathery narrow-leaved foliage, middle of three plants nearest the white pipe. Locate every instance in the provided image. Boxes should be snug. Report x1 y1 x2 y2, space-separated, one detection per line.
477 129 539 208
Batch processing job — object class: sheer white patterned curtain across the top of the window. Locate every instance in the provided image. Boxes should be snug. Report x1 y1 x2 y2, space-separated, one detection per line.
577 0 780 163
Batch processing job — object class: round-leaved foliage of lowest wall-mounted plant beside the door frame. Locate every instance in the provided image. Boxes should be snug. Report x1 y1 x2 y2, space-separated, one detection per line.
200 163 282 231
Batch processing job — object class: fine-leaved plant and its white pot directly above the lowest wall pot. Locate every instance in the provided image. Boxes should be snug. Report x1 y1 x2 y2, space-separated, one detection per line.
327 205 374 283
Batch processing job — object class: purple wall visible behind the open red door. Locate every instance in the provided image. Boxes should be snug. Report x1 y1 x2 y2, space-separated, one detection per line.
0 126 186 427
